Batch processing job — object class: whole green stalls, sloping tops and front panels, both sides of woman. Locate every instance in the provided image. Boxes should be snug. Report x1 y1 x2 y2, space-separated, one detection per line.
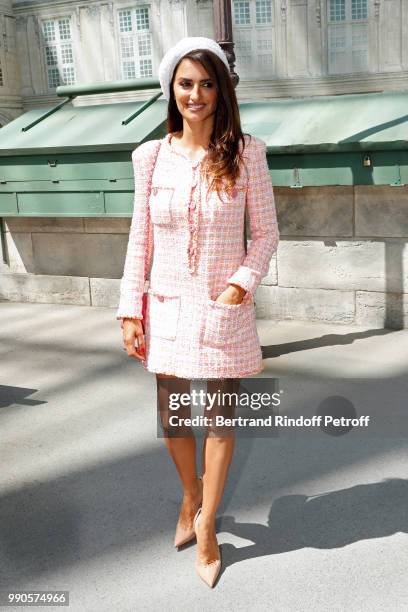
0 82 408 217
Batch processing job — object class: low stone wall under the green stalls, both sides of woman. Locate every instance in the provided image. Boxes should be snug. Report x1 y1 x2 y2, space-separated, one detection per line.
0 185 408 328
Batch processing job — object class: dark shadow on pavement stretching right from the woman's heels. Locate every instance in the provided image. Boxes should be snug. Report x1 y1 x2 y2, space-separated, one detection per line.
217 478 408 570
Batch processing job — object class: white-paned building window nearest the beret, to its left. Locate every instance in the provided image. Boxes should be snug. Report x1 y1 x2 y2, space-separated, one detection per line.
118 6 153 79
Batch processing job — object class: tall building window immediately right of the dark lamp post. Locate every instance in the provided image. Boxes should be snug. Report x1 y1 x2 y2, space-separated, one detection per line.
232 0 275 78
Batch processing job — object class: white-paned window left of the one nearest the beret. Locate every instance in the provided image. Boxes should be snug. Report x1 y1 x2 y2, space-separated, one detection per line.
42 17 75 89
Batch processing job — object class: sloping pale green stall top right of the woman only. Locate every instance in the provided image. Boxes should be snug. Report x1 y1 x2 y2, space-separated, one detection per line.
240 90 408 153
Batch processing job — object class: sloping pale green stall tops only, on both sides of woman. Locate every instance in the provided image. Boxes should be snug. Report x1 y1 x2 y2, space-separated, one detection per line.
0 91 408 155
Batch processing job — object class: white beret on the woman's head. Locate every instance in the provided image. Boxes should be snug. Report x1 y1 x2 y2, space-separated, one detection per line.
159 36 229 100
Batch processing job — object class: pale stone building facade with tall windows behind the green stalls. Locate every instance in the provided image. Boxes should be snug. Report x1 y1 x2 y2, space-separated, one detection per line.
0 0 408 115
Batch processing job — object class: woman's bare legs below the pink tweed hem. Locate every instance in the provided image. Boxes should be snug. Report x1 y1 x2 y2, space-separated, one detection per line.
156 374 239 563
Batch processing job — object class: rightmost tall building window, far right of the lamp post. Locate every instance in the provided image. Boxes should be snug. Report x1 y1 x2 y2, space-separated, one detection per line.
328 0 368 74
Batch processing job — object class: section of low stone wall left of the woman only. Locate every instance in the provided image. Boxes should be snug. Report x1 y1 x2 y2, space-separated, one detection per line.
0 217 126 307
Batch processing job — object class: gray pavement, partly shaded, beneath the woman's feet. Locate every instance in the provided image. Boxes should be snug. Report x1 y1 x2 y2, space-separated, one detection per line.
0 302 408 612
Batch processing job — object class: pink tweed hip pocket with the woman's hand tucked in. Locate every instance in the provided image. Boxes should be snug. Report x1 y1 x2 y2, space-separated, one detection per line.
203 299 254 348
